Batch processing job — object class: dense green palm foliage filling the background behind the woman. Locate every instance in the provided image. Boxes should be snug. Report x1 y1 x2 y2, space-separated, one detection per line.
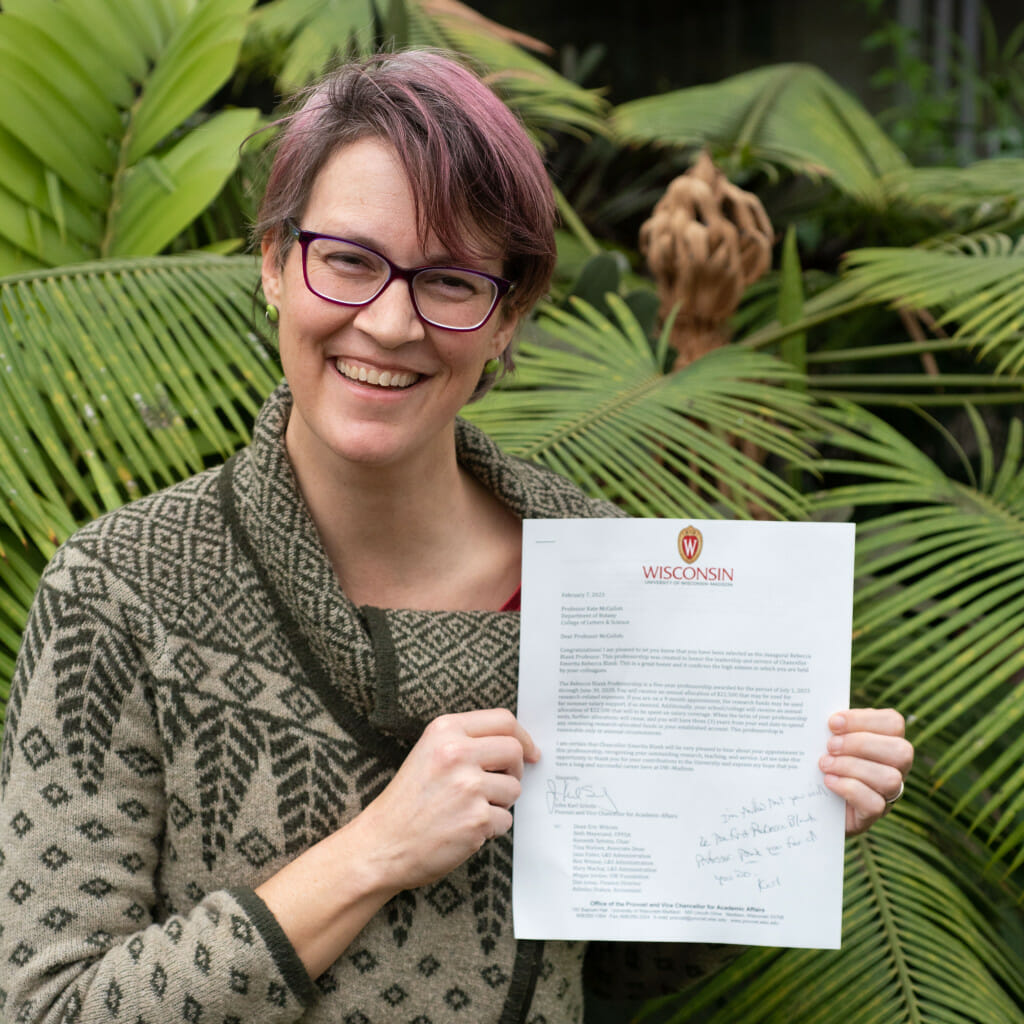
0 0 1024 1024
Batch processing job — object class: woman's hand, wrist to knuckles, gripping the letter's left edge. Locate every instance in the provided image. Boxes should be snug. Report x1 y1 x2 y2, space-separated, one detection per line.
354 708 540 892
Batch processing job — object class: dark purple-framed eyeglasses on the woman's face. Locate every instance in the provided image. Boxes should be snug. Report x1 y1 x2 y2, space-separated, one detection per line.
285 217 514 331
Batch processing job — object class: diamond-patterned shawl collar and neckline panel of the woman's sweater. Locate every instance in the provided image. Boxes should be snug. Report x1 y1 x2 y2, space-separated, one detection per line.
222 384 622 743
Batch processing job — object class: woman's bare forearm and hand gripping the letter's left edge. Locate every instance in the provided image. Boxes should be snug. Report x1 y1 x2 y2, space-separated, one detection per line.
256 708 540 978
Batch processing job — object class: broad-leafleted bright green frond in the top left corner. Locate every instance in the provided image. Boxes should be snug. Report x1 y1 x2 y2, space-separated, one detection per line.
0 0 258 274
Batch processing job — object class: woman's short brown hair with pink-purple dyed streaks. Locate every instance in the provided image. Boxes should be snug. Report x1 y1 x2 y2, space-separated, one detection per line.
254 50 556 387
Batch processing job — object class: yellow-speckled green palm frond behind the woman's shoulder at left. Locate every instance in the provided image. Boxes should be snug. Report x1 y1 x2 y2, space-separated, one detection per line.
0 255 279 737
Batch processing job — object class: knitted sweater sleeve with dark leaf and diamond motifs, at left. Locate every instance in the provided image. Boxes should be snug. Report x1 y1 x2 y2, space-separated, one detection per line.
0 556 314 1024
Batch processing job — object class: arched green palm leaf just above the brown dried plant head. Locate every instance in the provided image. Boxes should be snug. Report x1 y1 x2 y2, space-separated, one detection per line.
612 65 906 205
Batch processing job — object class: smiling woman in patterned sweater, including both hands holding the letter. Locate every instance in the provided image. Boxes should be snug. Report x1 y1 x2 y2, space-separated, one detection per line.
0 53 912 1022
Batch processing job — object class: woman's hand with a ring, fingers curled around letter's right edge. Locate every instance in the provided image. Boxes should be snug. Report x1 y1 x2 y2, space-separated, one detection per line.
818 708 913 836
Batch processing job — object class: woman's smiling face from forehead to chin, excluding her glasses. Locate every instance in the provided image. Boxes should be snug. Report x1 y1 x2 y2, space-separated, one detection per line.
263 138 516 479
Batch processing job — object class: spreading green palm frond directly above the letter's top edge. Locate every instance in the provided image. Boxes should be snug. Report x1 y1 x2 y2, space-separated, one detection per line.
467 295 814 519
